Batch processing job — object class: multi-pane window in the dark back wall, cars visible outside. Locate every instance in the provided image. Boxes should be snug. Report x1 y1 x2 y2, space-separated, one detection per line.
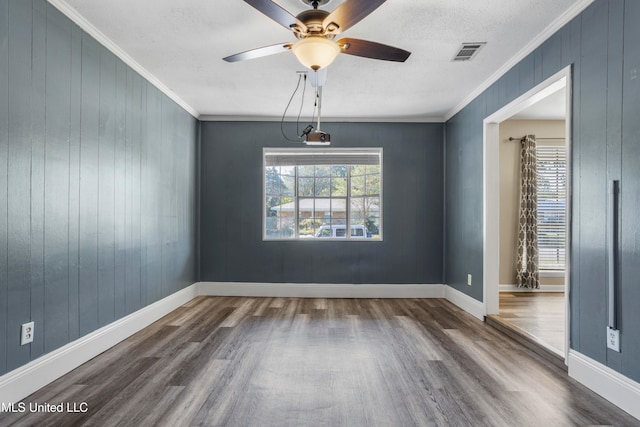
263 148 382 241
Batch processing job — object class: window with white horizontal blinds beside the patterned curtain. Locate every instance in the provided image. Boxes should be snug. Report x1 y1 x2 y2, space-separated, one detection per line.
536 145 567 271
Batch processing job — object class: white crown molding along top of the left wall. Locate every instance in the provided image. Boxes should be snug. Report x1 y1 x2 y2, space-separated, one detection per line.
47 0 199 118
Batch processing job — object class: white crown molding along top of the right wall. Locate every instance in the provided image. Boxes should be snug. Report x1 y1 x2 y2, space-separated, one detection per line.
444 0 595 121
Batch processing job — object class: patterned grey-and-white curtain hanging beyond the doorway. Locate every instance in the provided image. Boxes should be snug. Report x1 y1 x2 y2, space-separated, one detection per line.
516 135 540 289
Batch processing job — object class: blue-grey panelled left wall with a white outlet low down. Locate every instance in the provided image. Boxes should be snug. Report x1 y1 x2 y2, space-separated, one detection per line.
0 0 198 375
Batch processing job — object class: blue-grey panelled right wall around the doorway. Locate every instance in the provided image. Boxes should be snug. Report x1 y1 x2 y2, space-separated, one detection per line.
445 0 640 381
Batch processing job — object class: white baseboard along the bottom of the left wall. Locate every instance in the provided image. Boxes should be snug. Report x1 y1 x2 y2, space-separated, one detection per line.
0 285 197 404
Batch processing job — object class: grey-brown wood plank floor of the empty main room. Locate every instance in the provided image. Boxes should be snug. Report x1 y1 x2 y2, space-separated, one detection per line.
0 297 640 427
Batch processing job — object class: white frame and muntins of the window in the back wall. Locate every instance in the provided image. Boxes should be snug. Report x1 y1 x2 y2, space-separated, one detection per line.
262 147 384 242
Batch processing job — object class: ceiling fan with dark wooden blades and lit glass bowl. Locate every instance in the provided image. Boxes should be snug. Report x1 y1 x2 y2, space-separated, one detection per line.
223 0 411 71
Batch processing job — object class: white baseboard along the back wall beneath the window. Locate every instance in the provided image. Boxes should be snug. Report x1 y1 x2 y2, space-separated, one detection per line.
196 282 445 298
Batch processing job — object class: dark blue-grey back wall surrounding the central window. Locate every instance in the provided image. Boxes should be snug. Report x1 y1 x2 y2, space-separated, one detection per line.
200 122 443 283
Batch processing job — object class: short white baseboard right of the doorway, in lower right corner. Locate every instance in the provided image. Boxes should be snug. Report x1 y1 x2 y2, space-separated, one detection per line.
569 350 640 420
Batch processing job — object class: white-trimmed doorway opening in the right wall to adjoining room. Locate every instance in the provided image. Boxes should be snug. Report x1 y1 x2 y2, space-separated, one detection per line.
483 67 571 360
